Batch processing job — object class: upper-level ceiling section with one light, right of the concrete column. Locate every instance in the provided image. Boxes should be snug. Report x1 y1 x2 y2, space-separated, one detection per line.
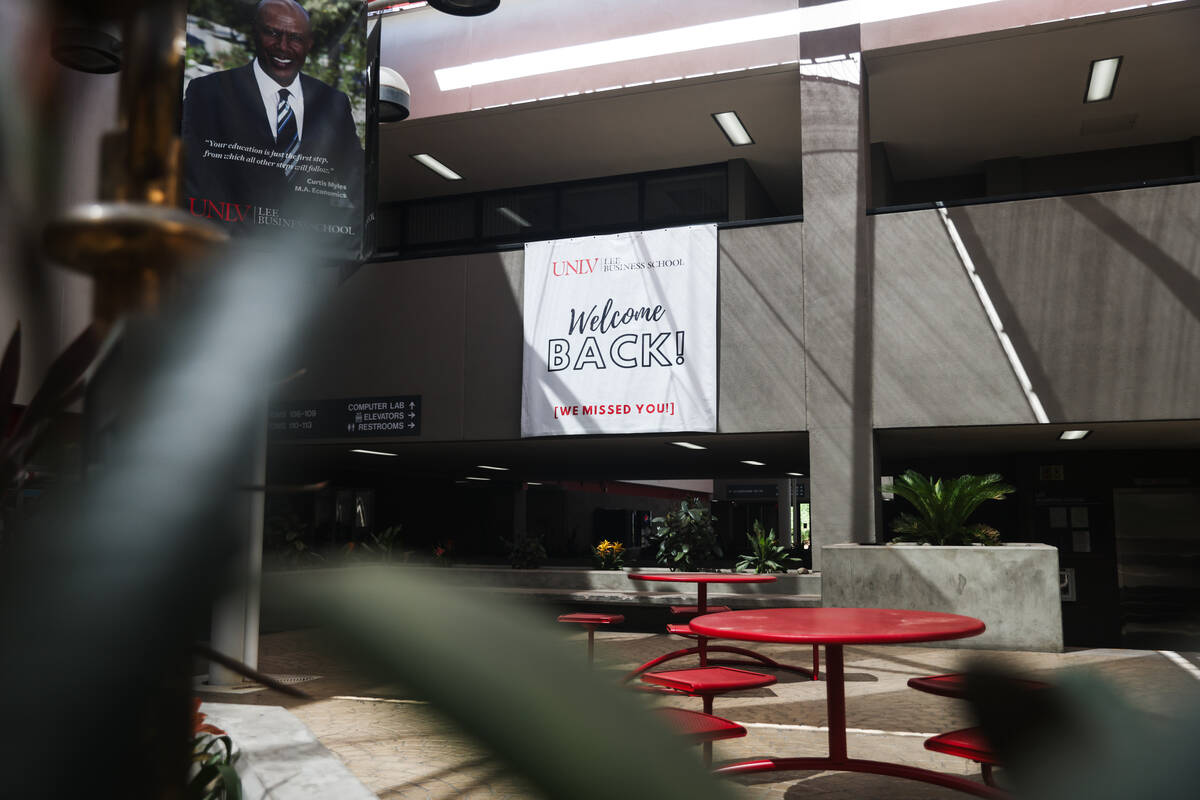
864 4 1200 181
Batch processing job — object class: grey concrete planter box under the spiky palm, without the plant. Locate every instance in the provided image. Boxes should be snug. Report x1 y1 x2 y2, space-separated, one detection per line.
821 545 1062 652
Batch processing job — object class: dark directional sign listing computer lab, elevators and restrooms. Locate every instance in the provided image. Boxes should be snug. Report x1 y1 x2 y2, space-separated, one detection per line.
269 395 421 439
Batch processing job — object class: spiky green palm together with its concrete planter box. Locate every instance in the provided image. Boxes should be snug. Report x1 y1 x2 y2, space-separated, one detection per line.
821 470 1062 652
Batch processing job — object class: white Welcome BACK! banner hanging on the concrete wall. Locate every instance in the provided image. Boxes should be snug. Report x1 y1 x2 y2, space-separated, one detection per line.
521 225 716 437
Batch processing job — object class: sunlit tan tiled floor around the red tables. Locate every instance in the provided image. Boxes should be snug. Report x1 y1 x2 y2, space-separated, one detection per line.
199 627 1200 800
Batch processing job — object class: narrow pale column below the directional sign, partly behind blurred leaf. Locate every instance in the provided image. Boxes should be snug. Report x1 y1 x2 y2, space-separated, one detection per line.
209 402 266 686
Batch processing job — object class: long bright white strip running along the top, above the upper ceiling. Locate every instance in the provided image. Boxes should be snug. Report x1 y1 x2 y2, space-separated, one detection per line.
433 0 1000 91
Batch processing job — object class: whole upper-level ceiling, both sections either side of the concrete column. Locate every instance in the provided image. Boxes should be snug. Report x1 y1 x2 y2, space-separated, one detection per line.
380 1 1200 203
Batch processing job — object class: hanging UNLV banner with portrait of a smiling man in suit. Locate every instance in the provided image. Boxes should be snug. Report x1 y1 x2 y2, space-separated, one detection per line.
181 0 374 261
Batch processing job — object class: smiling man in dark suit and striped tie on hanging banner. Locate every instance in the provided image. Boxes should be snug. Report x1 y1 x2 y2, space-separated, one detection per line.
182 0 364 247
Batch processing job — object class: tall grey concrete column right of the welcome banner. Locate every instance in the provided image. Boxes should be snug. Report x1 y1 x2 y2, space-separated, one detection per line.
800 26 878 570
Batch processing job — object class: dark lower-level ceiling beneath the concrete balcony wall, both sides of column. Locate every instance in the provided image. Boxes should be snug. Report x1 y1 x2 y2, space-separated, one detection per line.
270 420 1200 481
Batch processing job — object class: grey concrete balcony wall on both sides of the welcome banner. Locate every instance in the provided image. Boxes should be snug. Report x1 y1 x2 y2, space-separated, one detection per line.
288 175 1200 441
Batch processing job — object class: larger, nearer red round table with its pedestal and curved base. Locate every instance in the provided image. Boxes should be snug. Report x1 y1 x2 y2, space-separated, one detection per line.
691 608 993 798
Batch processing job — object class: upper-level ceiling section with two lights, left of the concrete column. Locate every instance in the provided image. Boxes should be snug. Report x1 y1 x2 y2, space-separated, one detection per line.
379 65 800 210
